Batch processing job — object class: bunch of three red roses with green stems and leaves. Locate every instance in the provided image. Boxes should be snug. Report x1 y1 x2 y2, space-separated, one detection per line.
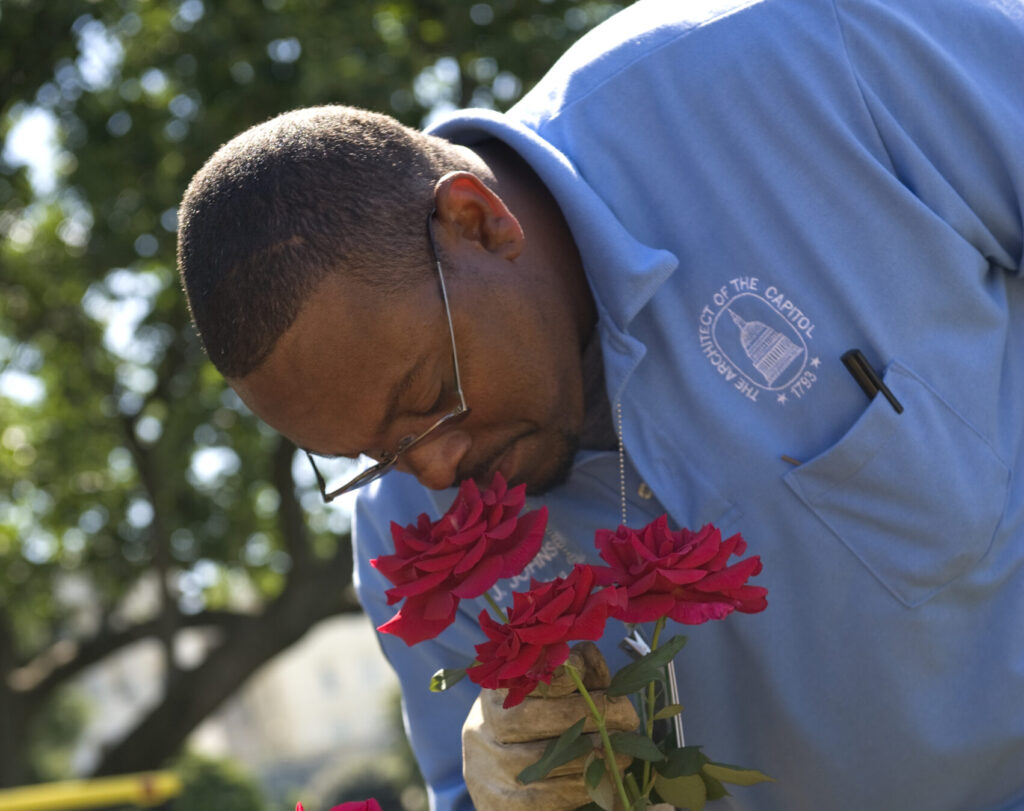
371 474 771 811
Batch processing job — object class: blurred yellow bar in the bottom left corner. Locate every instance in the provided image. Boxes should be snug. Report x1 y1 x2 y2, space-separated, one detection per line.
0 771 181 811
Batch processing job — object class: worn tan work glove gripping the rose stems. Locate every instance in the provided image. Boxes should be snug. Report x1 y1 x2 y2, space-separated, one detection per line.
462 642 640 811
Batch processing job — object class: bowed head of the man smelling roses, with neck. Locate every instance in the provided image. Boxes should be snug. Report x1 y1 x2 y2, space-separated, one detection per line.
179 101 593 489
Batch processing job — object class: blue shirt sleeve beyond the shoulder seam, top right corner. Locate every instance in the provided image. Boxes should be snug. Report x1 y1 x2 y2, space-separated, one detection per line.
834 0 1024 273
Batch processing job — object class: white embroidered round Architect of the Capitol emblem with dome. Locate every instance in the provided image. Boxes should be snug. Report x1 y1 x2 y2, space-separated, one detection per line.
699 276 820 406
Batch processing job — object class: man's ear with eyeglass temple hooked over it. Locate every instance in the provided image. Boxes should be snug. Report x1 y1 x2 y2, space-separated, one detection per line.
434 172 525 259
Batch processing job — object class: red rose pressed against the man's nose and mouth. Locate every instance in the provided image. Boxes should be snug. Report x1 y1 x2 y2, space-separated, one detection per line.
370 473 548 645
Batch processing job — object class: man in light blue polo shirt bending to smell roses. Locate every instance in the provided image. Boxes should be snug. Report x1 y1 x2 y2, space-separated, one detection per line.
180 0 1024 811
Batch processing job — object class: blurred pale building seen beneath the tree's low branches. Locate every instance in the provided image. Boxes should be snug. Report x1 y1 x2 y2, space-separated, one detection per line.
65 615 403 811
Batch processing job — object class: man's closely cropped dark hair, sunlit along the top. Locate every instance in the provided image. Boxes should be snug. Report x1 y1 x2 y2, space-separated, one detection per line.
178 104 468 378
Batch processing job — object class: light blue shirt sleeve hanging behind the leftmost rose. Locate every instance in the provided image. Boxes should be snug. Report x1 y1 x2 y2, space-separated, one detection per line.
352 474 481 811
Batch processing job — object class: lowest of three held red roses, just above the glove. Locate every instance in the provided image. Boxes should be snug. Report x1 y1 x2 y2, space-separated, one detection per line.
466 564 625 708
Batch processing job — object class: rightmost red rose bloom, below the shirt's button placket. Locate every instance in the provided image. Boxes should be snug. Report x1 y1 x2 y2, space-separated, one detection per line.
594 515 768 625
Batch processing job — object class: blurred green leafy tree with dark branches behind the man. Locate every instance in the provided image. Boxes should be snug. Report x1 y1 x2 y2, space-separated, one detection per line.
0 0 617 785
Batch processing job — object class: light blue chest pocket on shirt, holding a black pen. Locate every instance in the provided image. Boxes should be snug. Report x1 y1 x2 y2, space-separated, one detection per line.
784 361 1010 606
